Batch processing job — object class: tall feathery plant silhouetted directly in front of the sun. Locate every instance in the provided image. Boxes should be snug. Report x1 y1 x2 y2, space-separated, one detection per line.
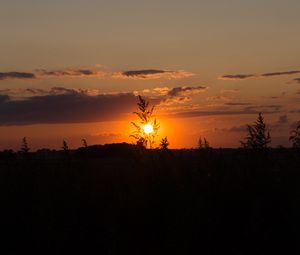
130 96 159 149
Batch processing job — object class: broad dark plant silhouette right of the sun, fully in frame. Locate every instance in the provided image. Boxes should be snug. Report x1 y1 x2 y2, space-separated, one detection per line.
240 112 271 149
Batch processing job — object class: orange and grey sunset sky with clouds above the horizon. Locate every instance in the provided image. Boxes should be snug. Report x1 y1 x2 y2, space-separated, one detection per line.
0 0 300 150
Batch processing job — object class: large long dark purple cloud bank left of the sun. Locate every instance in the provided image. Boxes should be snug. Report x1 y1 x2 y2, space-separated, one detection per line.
0 88 137 125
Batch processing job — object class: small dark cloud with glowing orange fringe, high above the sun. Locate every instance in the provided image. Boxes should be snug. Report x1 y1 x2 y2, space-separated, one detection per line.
113 69 195 80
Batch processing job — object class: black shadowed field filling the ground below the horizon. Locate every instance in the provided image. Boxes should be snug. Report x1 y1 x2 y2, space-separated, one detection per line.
0 144 300 255
